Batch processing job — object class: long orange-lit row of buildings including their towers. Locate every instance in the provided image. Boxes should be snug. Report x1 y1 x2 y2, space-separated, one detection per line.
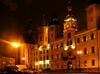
18 2 100 71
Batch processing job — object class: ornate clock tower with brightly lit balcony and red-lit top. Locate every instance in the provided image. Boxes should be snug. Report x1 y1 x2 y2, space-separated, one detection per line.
63 2 77 58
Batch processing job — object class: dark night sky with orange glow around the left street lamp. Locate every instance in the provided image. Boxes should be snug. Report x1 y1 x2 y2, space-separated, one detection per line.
0 0 90 56
